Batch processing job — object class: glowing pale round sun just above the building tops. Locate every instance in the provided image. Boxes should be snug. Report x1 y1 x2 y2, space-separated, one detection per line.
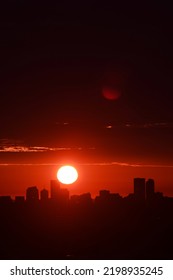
57 165 78 185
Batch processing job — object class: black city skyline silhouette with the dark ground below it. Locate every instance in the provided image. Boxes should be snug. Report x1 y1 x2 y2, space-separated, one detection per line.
0 178 173 259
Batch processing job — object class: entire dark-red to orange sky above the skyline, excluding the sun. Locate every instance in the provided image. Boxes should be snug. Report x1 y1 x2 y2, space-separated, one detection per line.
0 1 173 198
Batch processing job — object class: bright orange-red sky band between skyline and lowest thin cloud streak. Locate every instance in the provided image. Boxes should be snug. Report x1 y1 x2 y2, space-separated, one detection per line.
0 163 173 197
